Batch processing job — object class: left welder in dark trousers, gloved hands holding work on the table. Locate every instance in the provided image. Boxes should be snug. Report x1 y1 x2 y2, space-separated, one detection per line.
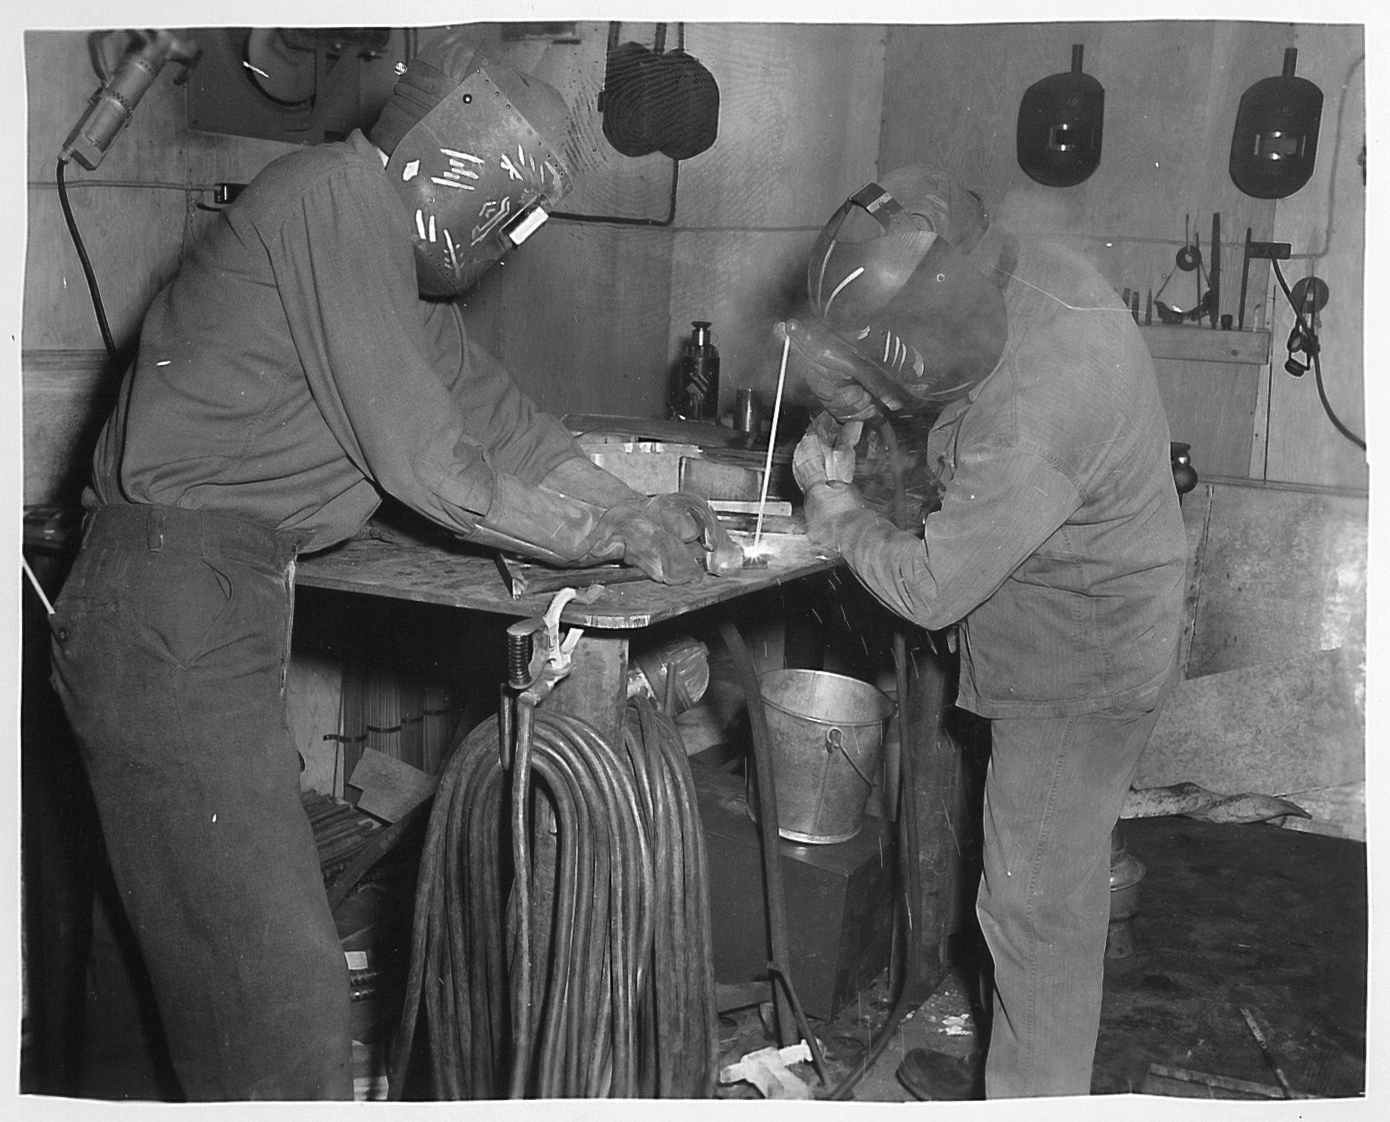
53 36 702 1100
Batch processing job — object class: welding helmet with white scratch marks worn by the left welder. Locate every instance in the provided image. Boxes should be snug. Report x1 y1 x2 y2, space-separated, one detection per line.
370 35 573 296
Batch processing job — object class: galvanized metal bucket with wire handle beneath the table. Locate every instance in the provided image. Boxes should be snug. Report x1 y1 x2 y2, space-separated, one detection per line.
748 670 894 845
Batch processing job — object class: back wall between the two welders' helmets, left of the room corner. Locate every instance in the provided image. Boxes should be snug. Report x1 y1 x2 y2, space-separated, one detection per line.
467 24 883 416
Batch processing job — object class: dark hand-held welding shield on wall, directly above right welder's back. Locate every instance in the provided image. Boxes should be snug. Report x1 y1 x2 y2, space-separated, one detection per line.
1017 43 1105 186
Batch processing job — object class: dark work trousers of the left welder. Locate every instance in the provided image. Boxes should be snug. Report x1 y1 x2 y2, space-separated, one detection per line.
50 505 353 1100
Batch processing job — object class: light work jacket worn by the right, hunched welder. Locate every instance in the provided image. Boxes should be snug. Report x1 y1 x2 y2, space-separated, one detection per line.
811 238 1186 717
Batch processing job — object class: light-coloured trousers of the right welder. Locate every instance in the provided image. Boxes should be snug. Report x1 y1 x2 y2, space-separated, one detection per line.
976 667 1172 1098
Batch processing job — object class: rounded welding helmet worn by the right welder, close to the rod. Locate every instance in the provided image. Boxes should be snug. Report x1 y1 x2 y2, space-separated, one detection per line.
787 165 1008 410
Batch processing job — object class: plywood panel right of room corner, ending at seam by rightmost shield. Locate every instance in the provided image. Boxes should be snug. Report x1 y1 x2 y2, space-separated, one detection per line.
881 21 1290 298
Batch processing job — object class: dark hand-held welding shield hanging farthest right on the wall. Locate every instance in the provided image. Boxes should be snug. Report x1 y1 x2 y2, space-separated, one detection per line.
1230 47 1322 199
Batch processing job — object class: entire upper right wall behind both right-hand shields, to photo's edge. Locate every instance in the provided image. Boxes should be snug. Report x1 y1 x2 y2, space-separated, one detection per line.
881 21 1366 487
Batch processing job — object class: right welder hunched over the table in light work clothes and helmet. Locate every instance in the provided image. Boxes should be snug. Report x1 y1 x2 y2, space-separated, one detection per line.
788 167 1186 1097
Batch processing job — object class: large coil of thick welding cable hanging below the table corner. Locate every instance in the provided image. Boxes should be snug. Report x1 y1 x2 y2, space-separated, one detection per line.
389 701 719 1100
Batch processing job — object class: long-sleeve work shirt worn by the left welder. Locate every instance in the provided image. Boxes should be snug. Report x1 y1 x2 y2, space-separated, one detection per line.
93 132 582 551
